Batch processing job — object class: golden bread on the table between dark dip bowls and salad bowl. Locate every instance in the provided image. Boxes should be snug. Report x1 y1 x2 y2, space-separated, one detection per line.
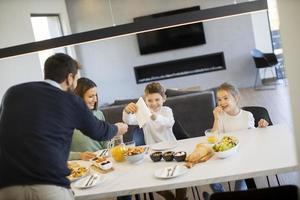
185 144 213 168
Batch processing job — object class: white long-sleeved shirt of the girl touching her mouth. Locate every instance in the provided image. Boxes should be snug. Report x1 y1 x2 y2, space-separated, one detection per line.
219 110 254 133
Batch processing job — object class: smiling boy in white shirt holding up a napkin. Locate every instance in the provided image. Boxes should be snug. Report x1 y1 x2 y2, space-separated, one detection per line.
123 83 176 144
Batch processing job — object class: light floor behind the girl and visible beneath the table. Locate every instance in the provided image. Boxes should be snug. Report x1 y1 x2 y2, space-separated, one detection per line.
102 80 299 200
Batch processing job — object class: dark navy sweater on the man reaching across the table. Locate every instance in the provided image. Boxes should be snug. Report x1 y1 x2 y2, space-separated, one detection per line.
0 82 117 188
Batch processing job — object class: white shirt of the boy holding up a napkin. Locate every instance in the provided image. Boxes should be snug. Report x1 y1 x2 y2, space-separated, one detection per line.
123 106 176 144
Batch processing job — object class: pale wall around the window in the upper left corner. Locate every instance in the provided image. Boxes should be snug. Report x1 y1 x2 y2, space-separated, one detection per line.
0 0 71 101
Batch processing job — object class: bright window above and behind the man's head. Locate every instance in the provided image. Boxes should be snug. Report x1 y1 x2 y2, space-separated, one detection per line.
31 14 67 71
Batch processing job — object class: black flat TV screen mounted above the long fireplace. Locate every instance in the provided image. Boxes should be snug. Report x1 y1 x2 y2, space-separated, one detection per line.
134 6 205 55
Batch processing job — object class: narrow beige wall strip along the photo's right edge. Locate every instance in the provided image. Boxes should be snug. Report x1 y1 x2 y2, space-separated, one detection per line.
277 0 300 182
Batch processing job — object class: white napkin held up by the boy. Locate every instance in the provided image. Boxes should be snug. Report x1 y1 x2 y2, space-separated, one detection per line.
135 97 151 128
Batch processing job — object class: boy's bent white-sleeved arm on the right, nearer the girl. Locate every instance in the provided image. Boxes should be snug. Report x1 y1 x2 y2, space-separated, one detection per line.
151 107 175 127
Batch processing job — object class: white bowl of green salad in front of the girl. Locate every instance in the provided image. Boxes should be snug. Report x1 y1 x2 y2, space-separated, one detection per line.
213 136 239 158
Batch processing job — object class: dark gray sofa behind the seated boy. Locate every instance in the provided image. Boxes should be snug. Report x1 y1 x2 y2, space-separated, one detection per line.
100 91 215 141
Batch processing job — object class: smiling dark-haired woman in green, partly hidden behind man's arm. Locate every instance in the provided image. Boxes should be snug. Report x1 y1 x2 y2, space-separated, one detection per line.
69 78 106 160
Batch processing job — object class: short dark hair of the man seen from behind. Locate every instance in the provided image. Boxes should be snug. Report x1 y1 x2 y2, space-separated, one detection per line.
44 53 80 83
